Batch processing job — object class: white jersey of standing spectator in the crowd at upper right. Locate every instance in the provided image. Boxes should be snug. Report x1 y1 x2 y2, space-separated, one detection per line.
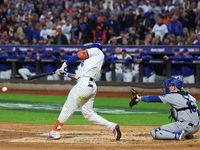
152 24 168 41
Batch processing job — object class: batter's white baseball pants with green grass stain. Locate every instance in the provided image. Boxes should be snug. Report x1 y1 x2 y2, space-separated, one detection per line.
58 77 116 131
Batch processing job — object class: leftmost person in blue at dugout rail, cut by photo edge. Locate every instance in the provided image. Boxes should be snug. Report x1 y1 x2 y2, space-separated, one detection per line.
0 47 11 79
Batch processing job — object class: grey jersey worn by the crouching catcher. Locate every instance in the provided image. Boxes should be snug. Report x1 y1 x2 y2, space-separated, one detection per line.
159 92 199 125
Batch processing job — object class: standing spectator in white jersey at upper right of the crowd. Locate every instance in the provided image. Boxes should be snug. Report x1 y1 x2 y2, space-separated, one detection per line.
152 17 168 41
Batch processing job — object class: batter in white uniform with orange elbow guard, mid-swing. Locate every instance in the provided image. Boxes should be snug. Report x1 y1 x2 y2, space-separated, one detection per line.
47 43 121 140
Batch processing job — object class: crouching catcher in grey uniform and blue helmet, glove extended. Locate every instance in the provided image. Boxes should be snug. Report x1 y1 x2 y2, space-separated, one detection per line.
129 77 200 140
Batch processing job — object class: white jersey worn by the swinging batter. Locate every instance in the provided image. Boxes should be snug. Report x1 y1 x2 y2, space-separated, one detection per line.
75 48 104 80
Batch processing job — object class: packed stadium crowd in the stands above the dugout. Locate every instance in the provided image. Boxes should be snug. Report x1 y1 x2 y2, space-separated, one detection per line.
0 0 200 45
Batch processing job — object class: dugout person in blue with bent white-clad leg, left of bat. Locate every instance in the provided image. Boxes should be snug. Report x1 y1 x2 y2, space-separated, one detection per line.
18 49 36 80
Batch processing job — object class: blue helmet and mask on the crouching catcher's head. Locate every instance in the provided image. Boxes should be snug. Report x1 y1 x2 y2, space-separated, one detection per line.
162 77 183 94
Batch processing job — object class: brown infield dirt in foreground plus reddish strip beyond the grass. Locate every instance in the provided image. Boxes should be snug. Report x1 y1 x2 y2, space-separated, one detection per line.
0 90 200 150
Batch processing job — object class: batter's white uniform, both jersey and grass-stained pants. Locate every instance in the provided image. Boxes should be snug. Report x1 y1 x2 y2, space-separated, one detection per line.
51 48 116 137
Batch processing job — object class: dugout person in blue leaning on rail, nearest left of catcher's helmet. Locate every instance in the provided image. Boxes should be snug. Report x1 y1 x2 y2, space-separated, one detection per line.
135 51 156 83
